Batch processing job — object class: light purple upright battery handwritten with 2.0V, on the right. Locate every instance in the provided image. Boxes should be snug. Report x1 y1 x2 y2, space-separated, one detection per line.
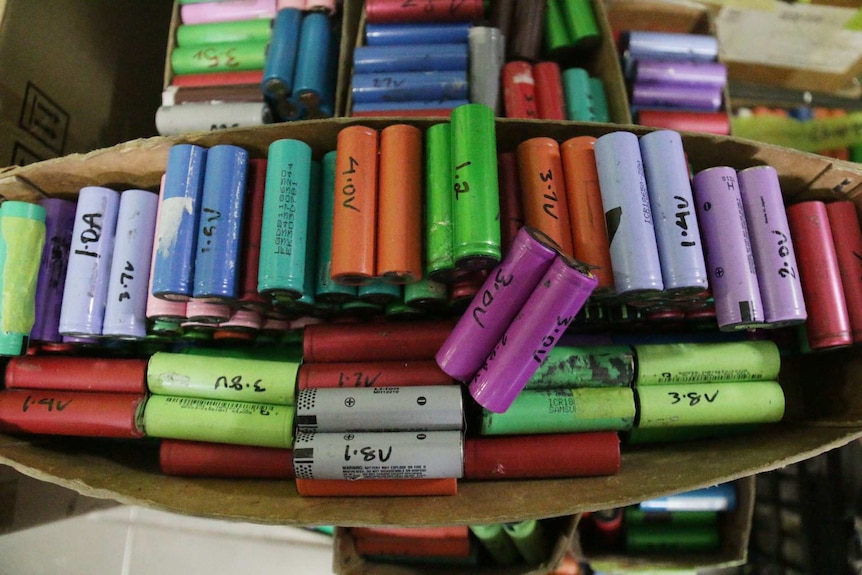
737 166 807 327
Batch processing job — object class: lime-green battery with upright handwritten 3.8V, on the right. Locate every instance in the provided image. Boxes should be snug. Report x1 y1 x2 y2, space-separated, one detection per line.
635 381 784 428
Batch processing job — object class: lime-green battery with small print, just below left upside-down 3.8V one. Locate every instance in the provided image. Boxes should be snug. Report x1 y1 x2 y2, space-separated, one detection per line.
144 395 295 448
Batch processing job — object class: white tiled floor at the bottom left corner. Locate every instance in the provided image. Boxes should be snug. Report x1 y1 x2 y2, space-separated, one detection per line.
0 506 333 575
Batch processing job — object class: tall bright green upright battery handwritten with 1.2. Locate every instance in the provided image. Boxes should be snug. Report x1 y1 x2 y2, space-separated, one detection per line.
450 104 501 271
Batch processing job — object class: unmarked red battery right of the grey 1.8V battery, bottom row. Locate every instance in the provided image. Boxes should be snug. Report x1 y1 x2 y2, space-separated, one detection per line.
464 431 621 479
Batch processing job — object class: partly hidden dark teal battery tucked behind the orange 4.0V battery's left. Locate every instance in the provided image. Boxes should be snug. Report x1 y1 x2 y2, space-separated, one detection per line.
314 150 357 304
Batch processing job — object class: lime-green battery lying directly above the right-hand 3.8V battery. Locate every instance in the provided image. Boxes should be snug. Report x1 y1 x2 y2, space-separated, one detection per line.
634 340 781 386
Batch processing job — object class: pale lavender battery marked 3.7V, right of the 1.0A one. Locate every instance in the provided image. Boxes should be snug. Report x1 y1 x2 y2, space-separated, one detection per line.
102 190 159 339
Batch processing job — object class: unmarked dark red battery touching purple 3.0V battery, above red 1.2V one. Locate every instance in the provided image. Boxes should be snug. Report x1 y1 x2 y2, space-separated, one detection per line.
302 320 455 363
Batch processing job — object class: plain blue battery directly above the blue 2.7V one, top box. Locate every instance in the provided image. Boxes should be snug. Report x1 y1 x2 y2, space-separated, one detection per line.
353 44 468 74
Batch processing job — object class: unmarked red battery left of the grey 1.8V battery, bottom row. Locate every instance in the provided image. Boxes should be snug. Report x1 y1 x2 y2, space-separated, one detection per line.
159 439 295 479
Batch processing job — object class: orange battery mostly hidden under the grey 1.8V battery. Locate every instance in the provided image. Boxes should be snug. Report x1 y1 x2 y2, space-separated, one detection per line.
296 477 458 497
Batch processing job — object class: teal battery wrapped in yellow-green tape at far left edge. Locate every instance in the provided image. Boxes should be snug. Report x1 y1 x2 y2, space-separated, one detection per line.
0 200 45 356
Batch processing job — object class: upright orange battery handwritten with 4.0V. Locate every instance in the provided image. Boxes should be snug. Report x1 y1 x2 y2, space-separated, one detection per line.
330 126 378 285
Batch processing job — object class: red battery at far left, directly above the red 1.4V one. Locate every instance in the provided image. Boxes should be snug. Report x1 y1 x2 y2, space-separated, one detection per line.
5 355 147 394
